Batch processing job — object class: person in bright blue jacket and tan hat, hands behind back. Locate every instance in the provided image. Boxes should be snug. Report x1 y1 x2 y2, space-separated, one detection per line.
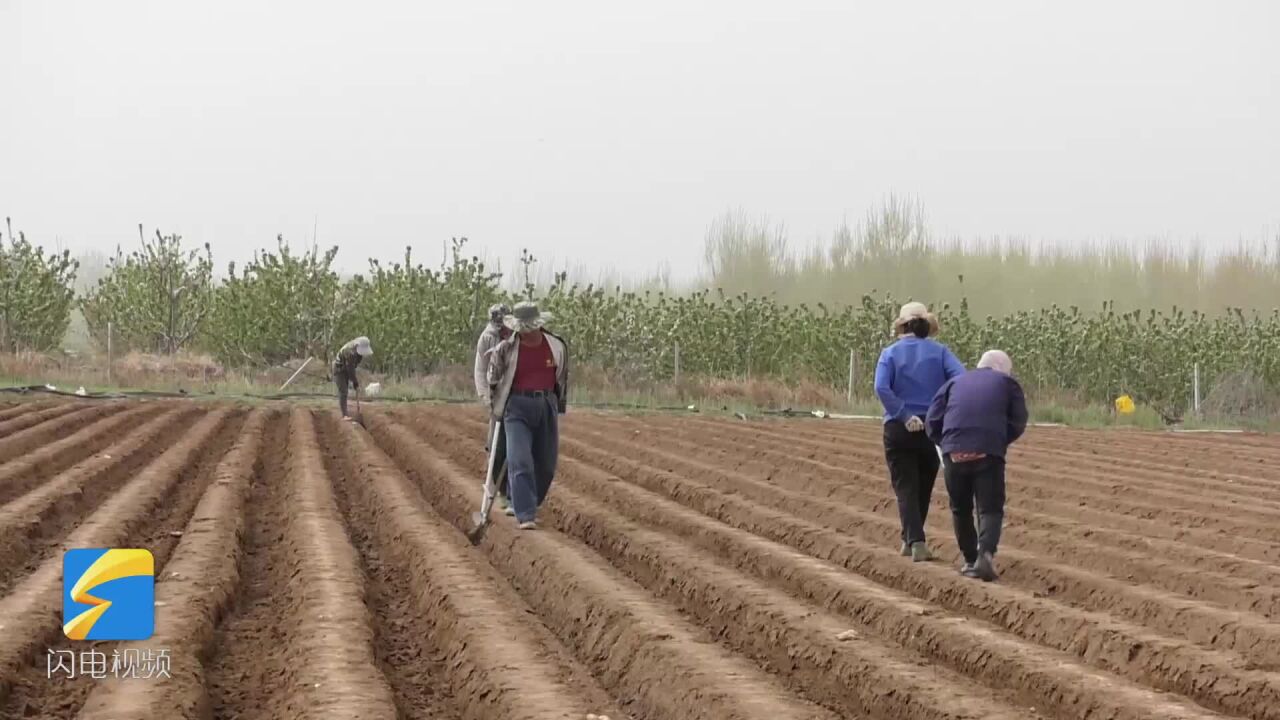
876 302 964 562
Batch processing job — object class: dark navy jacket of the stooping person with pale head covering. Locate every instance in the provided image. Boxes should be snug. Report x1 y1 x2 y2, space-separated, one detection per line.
924 368 1027 457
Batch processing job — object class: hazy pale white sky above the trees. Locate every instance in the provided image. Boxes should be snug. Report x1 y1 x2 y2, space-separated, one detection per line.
0 0 1280 277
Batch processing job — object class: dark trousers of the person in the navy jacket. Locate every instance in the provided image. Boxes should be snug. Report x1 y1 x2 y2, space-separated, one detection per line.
946 456 1005 564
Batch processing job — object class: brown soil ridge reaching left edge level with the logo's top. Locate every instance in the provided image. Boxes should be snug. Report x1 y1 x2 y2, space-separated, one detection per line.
0 407 195 594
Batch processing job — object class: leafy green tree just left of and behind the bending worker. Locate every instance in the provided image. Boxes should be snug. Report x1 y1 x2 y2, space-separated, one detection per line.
206 236 345 364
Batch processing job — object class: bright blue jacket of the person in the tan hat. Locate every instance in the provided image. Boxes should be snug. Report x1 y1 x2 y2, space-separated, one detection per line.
876 336 964 423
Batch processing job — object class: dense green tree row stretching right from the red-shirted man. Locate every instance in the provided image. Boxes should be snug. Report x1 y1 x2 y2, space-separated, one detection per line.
529 274 1280 421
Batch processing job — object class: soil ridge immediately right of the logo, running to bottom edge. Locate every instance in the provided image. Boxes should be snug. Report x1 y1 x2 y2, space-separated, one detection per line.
79 410 268 720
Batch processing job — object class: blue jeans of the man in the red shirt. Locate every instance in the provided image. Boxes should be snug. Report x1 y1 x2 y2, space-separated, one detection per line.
502 392 559 523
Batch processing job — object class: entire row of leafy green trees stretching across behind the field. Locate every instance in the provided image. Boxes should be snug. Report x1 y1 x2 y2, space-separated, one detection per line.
0 215 1280 416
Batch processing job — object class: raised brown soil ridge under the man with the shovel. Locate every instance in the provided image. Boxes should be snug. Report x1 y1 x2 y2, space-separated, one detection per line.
376 412 836 720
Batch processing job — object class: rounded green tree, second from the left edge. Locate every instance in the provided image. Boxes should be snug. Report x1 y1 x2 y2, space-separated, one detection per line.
81 225 214 354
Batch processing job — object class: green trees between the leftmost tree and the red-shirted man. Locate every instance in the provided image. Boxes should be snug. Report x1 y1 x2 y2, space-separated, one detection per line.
72 227 499 373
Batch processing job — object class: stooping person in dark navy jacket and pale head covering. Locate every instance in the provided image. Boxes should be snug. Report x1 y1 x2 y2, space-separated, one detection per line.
924 350 1027 583
